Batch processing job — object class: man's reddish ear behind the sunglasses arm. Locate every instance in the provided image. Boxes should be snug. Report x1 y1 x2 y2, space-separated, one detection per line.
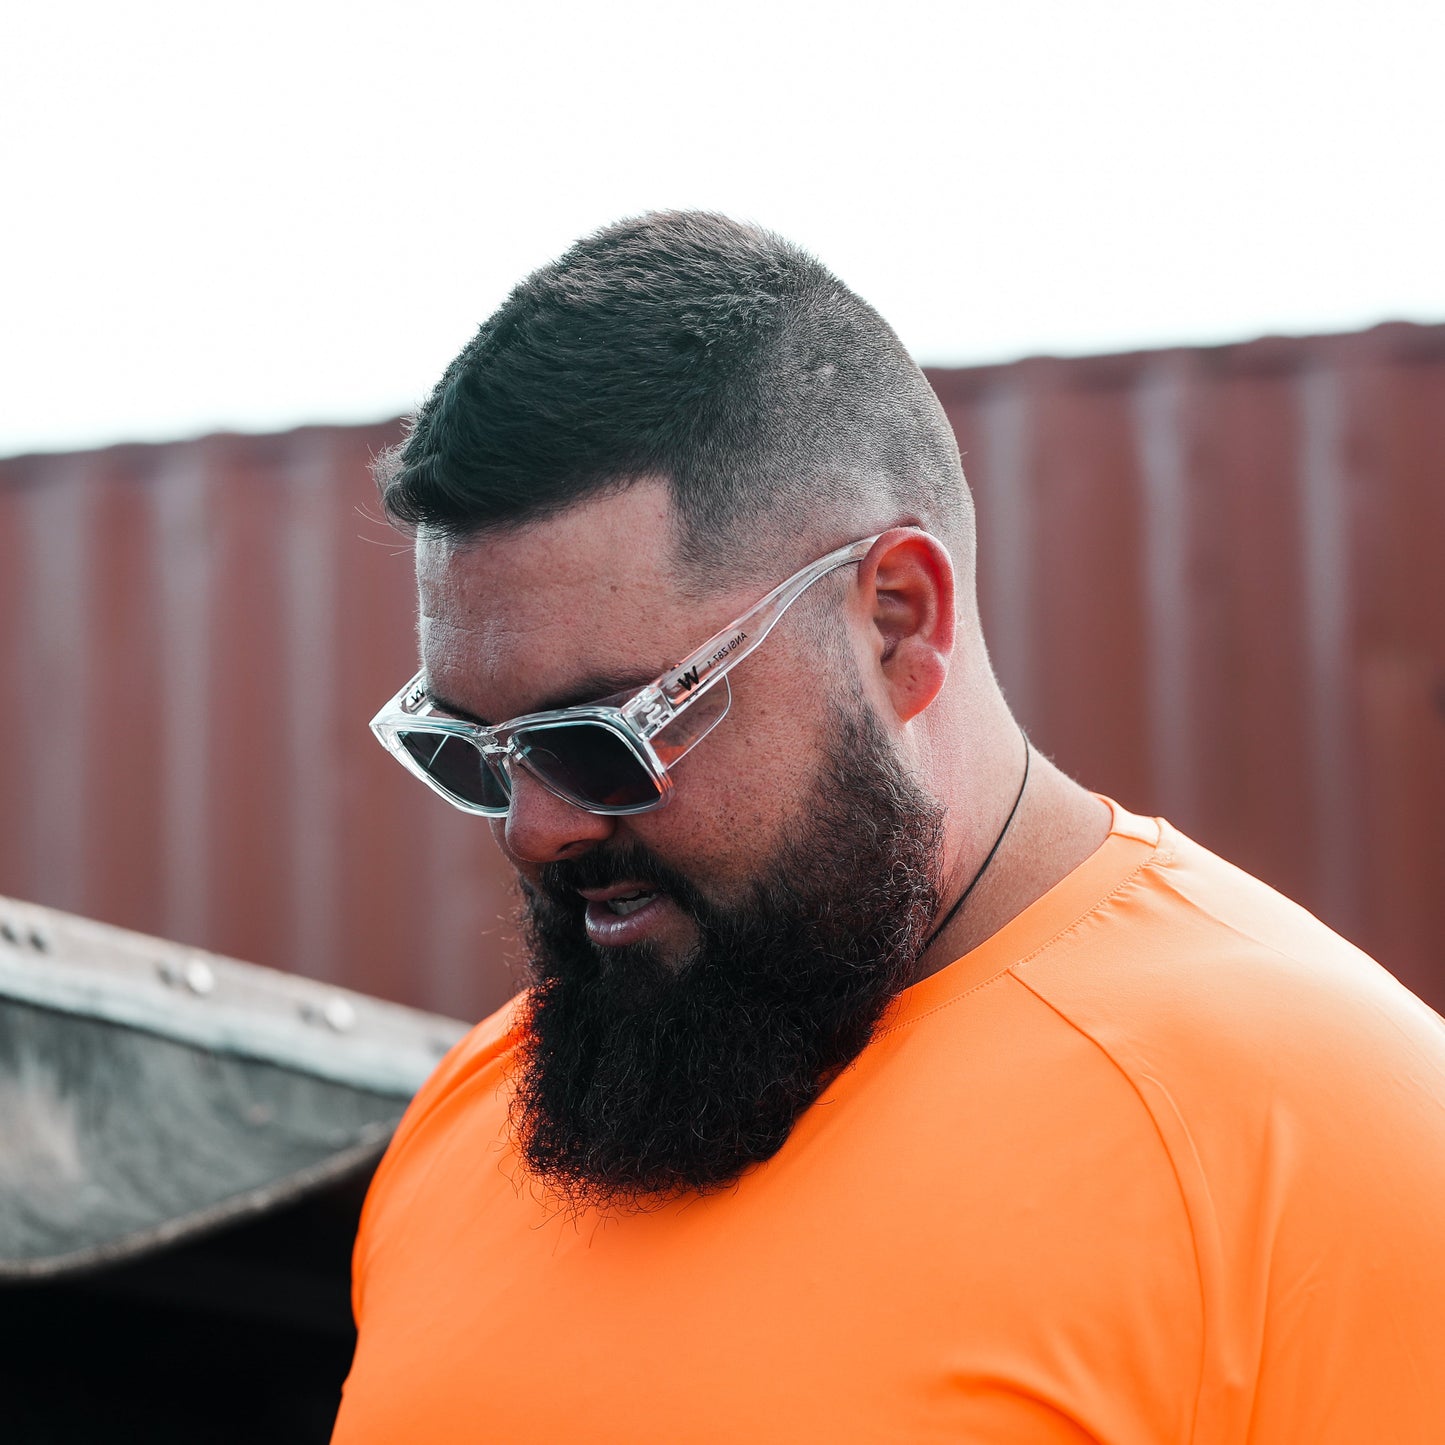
858 527 955 723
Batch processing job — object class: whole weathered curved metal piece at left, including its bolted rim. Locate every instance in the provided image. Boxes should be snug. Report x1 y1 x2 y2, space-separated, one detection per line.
0 897 465 1283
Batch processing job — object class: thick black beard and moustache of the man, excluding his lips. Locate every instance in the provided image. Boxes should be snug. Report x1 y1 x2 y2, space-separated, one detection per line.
512 707 944 1211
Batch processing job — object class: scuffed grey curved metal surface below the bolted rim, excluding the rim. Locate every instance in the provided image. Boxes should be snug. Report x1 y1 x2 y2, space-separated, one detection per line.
0 998 395 1283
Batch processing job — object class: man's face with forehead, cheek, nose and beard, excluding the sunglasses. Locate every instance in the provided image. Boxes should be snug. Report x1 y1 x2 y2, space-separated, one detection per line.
418 483 941 1204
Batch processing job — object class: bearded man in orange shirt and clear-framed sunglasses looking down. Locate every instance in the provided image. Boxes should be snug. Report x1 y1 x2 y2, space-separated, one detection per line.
335 214 1445 1445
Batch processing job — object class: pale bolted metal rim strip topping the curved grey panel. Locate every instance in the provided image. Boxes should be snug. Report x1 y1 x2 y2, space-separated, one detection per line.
0 897 468 1098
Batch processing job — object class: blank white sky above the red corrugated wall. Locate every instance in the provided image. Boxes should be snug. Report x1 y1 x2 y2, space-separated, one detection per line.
0 0 1445 454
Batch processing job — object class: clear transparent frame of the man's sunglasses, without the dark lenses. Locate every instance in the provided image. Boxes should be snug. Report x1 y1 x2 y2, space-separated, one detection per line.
371 532 886 818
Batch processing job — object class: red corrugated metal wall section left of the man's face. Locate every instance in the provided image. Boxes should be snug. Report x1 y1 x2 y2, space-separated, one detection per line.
0 426 509 1017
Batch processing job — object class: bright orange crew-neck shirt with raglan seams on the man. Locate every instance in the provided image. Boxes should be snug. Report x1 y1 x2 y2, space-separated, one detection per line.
334 806 1445 1445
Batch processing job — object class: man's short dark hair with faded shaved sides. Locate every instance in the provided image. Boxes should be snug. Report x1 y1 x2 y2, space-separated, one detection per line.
377 211 970 569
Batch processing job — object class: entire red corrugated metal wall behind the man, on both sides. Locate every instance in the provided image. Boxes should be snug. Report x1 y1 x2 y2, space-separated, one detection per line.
0 325 1445 1017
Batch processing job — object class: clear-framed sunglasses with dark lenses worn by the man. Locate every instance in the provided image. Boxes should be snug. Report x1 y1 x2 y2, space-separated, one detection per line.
371 533 883 818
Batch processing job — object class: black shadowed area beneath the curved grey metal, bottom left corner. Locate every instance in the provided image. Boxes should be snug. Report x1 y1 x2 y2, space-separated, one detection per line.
0 1172 367 1445
